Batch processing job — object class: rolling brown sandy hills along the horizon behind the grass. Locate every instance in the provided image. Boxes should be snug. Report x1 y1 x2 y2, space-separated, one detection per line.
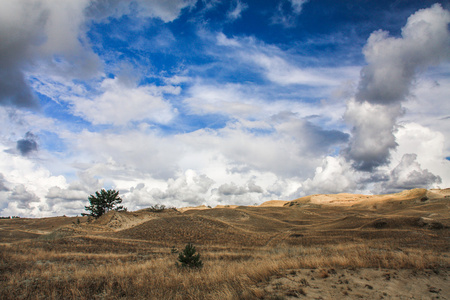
0 189 450 246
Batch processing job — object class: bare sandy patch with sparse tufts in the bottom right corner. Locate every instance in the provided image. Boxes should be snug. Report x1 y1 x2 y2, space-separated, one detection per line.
257 269 450 299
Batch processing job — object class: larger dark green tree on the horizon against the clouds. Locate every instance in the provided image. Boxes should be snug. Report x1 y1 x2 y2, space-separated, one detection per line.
81 189 126 219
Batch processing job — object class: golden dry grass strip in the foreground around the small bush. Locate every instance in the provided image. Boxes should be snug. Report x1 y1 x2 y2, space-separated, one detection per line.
0 241 449 299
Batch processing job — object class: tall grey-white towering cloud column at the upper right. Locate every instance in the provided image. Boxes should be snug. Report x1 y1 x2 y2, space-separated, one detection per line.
345 4 450 171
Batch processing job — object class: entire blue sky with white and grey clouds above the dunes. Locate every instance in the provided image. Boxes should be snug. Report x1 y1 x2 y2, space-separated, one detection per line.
0 0 450 217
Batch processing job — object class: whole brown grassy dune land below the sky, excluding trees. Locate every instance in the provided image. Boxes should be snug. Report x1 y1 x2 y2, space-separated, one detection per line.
0 189 450 299
